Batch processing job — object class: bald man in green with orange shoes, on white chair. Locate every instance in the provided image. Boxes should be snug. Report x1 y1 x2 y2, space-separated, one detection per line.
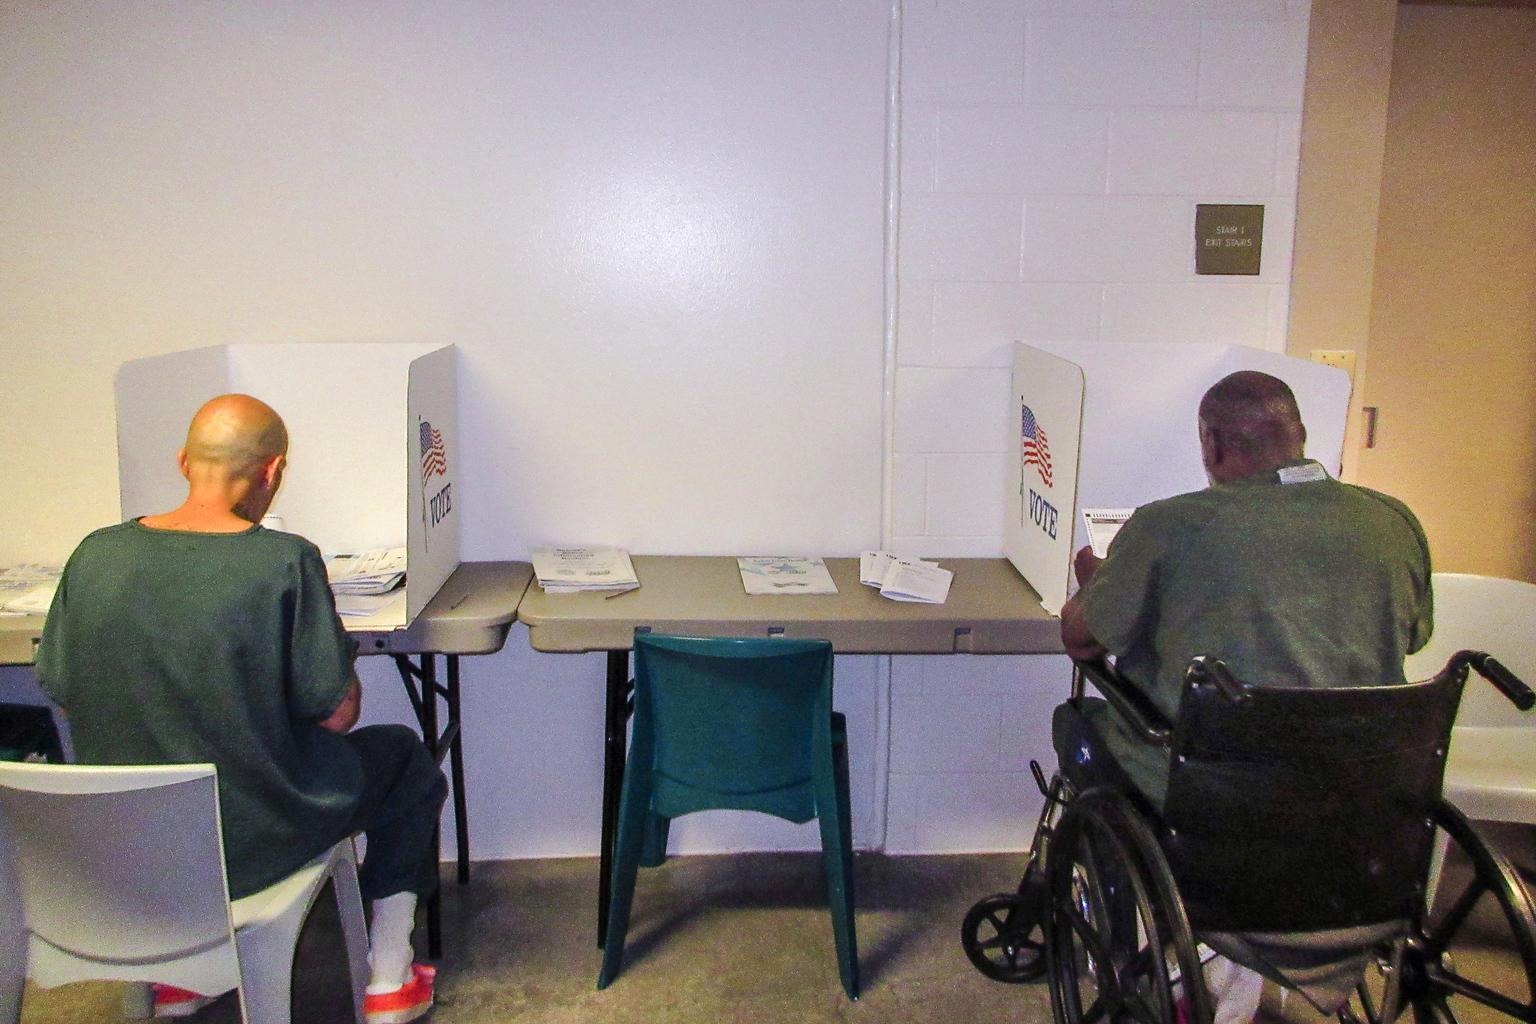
37 395 447 1024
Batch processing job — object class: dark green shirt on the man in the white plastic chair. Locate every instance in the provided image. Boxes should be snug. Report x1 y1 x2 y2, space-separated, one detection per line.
37 520 362 898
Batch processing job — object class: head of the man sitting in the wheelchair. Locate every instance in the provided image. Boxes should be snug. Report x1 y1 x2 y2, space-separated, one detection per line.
1200 370 1307 470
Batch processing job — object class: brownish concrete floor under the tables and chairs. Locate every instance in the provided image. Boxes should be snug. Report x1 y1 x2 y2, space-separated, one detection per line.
22 854 1524 1024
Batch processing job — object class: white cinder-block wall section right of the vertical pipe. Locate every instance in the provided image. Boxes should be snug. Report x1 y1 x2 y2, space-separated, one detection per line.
886 0 1309 852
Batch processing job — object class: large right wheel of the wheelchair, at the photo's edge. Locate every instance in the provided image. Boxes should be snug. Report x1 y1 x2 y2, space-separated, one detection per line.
1338 803 1536 1024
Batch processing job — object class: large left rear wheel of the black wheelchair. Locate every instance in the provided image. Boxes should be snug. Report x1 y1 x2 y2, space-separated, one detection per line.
1046 789 1212 1024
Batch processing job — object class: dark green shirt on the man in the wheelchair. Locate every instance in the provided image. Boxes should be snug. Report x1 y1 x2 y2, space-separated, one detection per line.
1081 461 1433 804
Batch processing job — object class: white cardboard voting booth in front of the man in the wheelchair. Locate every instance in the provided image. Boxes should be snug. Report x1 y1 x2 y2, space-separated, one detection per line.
1003 342 1350 614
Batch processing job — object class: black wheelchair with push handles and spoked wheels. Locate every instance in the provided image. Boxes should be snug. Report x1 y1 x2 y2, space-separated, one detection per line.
960 651 1536 1024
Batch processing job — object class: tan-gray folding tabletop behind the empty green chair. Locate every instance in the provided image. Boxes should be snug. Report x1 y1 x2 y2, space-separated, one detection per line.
518 554 1061 654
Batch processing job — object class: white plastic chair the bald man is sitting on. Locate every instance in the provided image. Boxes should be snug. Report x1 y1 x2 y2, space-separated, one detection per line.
0 761 369 1024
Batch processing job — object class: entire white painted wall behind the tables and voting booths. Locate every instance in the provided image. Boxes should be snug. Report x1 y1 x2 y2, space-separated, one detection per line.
0 0 1307 857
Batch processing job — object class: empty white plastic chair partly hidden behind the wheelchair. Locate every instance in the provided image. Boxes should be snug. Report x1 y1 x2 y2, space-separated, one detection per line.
1404 573 1536 824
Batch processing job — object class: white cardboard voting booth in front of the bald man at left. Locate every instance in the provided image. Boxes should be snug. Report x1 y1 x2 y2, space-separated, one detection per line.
117 342 461 629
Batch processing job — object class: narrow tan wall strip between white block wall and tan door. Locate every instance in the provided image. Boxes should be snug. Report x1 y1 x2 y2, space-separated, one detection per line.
1286 0 1398 488
